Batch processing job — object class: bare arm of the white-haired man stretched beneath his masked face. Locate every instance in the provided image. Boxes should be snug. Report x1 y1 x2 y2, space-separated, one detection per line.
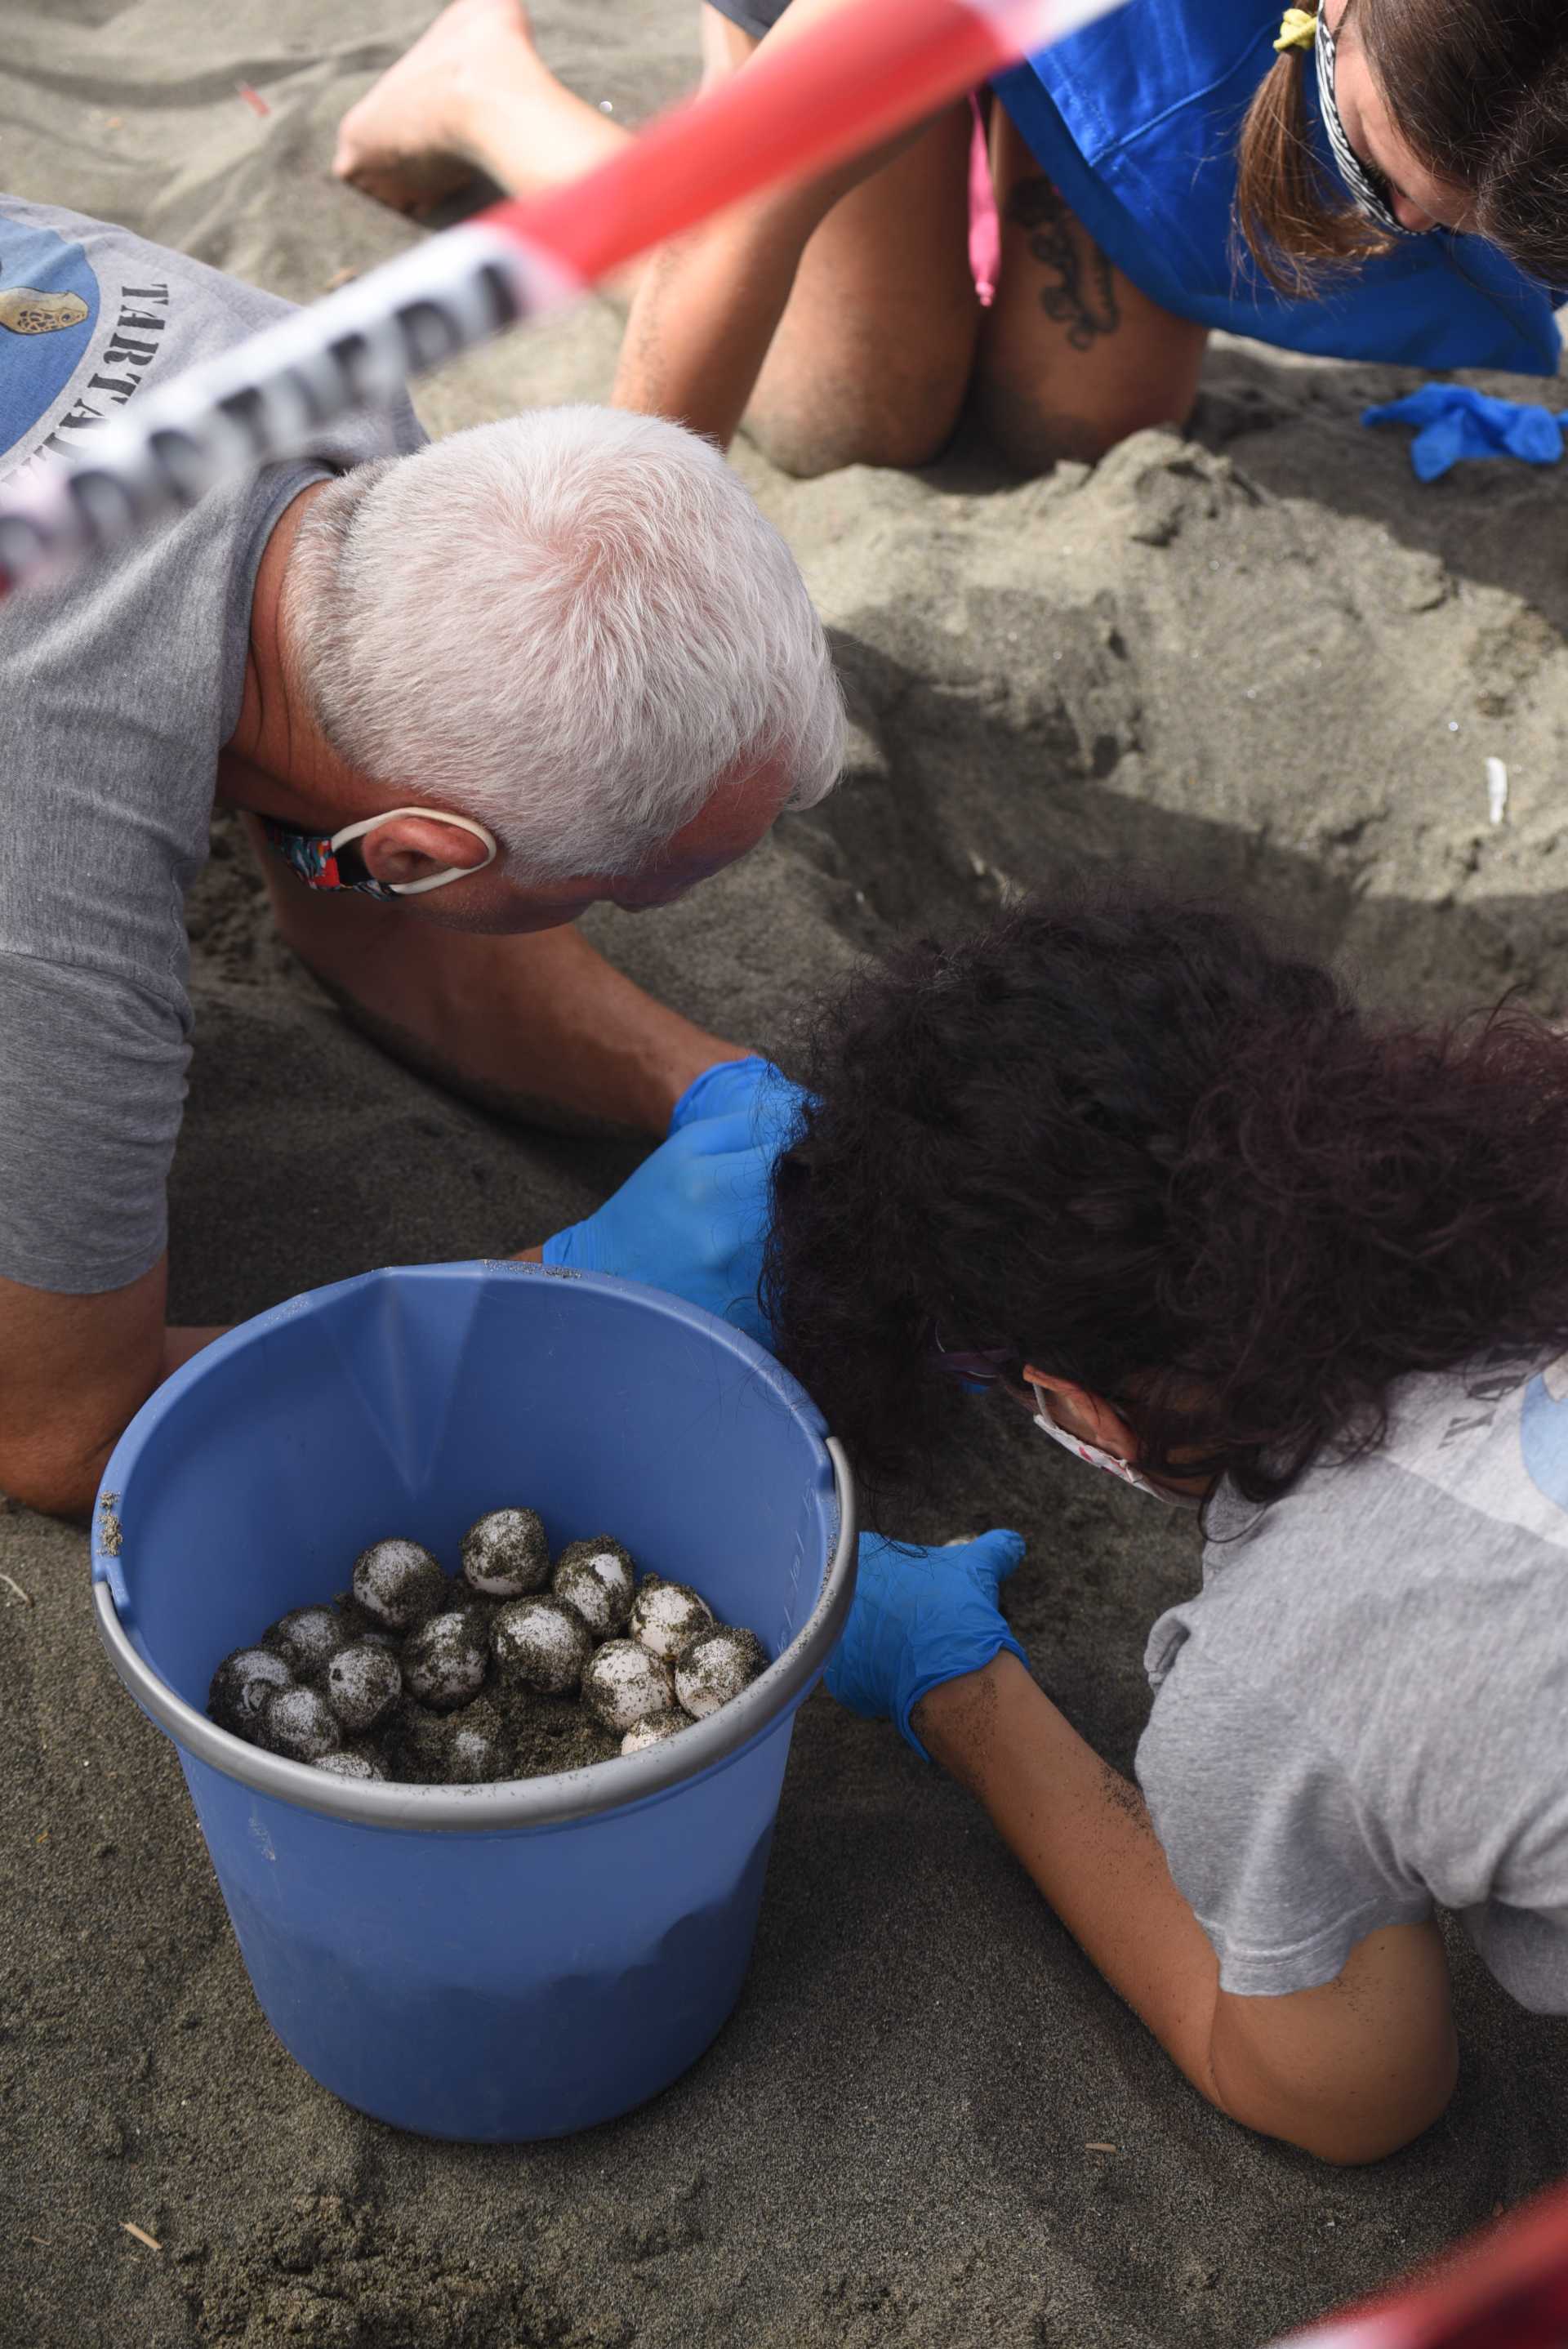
247 822 746 1134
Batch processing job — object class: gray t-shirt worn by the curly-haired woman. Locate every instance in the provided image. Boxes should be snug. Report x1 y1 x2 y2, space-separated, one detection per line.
1138 1355 1568 2013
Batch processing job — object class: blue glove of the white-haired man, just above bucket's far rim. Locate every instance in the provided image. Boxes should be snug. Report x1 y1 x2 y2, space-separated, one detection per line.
542 1059 800 1346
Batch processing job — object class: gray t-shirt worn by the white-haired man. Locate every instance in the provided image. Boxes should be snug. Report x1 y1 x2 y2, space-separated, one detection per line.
0 198 422 1292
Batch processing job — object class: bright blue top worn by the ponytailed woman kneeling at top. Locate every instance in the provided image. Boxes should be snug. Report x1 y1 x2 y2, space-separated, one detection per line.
996 0 1561 376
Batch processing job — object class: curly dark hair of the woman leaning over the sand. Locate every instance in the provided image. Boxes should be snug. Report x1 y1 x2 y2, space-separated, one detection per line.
763 895 1568 1501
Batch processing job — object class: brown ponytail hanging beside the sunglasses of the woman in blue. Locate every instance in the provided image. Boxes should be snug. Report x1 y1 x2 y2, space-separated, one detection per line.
1235 49 1392 301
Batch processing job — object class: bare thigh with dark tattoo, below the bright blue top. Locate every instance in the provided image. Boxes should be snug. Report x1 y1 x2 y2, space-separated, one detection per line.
977 105 1209 472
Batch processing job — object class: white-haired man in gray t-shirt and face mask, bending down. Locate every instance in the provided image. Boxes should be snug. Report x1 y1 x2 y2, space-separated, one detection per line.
0 199 843 1510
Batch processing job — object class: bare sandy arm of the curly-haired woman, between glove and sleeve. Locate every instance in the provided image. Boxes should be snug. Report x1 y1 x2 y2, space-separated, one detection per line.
915 1654 1458 2161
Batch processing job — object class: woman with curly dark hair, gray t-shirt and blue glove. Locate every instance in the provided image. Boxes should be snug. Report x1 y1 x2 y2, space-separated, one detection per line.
746 900 1568 2161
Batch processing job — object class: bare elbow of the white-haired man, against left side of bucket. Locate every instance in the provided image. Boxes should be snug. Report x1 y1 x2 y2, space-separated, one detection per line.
0 1257 218 1518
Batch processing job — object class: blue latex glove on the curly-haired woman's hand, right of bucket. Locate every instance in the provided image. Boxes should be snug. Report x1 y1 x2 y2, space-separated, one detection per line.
824 1531 1028 1762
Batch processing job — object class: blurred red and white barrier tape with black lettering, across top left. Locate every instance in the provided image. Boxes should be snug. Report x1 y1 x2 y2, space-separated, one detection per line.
0 0 1120 595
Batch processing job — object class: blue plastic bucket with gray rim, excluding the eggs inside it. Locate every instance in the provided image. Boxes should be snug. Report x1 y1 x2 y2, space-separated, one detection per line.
91 1264 854 2140
